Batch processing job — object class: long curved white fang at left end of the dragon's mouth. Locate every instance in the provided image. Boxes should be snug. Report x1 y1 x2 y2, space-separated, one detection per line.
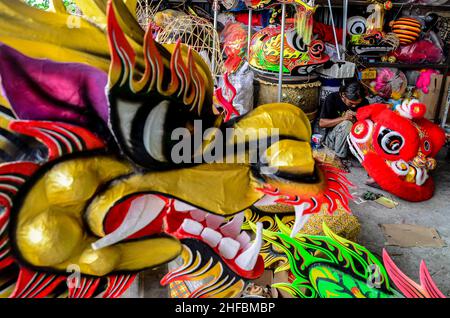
92 194 166 250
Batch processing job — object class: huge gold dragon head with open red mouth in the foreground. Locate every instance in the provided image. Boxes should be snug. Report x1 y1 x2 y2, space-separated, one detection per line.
0 0 350 297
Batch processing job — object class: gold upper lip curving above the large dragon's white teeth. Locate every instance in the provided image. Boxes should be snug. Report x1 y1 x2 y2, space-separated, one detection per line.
86 164 263 231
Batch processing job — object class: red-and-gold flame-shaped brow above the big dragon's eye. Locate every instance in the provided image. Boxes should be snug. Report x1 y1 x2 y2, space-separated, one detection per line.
108 2 212 115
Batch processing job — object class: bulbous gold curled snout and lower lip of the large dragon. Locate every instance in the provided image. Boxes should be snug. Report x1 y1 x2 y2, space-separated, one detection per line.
16 156 181 276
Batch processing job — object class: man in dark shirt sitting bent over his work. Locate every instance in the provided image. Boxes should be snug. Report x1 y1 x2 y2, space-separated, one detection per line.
319 80 369 159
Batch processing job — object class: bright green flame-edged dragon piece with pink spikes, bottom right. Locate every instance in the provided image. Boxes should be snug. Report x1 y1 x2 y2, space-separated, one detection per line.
263 220 445 298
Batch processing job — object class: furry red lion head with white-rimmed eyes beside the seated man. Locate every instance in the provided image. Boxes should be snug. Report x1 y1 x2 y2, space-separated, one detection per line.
348 100 445 202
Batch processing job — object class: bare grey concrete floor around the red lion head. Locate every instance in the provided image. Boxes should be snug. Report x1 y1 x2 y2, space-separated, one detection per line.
127 150 450 298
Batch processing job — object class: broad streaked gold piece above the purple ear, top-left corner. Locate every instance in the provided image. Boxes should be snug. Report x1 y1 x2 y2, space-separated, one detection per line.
0 0 114 72
